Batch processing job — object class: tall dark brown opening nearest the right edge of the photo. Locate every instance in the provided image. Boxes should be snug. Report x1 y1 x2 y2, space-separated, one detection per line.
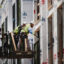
57 5 63 64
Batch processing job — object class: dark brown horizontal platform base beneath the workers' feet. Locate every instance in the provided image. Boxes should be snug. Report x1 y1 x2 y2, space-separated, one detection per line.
0 51 35 59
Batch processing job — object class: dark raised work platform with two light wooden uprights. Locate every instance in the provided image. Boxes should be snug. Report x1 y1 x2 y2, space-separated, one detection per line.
0 32 35 59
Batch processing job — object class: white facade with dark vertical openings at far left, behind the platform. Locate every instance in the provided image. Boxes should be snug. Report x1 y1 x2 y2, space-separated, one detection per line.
0 0 21 64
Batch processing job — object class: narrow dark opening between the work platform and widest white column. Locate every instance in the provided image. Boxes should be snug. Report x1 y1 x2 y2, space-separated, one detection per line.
34 30 40 64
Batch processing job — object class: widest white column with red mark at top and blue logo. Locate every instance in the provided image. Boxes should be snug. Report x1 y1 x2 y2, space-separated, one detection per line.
40 0 48 64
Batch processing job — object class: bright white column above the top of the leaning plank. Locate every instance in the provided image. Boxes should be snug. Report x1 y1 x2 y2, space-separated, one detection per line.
8 2 13 32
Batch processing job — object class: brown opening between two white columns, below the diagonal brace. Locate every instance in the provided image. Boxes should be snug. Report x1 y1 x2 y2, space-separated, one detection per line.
48 16 53 64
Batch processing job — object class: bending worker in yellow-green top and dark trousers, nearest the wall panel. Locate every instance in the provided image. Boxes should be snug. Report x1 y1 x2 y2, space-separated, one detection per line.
18 23 34 49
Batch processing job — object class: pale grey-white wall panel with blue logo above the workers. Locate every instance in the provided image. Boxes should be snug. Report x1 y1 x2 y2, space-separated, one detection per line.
21 0 34 23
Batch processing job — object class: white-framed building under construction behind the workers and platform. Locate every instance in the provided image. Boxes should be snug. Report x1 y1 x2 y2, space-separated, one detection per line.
0 0 64 64
